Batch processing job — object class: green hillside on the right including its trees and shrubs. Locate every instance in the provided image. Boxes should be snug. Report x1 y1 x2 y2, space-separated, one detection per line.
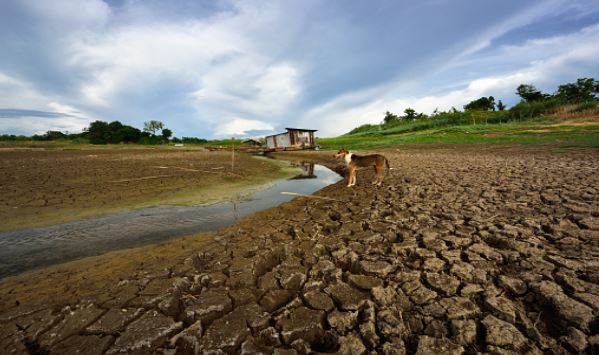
318 78 599 149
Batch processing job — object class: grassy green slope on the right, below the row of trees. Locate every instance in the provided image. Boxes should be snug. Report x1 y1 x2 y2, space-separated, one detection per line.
317 103 599 149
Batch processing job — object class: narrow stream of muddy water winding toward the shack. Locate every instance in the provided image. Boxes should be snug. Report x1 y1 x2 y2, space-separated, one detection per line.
0 163 341 279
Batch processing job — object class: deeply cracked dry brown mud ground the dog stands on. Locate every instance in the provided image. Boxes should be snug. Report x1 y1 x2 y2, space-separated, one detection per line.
0 147 599 354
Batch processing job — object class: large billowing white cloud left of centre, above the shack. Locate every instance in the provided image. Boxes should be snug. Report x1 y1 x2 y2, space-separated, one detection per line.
69 5 301 132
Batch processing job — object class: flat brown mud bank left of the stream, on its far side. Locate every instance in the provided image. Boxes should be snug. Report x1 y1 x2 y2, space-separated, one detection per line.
0 149 298 231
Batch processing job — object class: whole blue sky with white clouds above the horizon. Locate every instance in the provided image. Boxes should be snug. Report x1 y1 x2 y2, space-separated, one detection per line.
0 0 599 138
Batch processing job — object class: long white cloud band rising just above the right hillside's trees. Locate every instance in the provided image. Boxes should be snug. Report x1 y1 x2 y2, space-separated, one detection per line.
303 21 599 136
